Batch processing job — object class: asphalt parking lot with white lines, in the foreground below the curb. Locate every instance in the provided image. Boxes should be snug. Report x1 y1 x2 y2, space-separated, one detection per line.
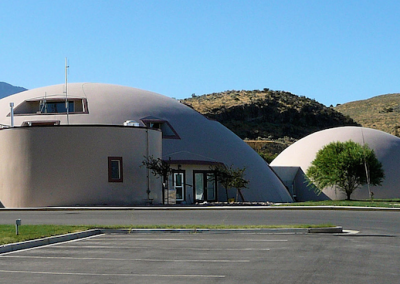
0 233 400 284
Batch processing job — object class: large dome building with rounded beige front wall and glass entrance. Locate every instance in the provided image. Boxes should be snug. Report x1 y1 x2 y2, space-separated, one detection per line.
0 83 293 207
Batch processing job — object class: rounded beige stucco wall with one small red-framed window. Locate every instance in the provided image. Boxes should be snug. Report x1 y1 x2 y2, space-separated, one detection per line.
0 126 162 207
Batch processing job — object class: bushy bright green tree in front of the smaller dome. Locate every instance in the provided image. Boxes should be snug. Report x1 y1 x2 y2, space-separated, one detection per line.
306 140 385 200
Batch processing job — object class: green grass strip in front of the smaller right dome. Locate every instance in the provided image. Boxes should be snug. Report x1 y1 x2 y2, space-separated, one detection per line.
282 198 400 208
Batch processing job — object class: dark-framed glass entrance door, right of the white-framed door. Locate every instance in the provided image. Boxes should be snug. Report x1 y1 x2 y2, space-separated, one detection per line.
194 172 217 202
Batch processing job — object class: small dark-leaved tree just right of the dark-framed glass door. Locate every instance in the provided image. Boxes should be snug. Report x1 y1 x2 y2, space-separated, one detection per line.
211 164 249 201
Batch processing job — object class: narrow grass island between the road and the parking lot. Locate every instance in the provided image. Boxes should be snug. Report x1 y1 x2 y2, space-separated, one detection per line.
0 224 334 245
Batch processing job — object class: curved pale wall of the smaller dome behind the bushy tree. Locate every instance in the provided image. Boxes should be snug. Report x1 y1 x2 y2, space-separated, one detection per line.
271 127 400 199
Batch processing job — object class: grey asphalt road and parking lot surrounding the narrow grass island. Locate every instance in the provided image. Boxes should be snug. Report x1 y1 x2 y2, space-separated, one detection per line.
0 207 400 284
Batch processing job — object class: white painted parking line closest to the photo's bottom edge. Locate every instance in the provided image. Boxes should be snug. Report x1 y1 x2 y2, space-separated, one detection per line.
0 270 225 278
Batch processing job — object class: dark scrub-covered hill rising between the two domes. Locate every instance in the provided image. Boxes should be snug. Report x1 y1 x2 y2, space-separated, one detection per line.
181 88 357 139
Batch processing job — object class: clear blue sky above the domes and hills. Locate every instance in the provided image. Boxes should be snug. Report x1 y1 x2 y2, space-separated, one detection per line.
0 0 400 106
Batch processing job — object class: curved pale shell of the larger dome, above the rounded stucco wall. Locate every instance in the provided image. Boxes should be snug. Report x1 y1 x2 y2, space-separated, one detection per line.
0 83 292 202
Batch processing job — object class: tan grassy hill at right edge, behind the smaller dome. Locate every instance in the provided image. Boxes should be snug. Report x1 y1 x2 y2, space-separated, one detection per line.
335 94 400 136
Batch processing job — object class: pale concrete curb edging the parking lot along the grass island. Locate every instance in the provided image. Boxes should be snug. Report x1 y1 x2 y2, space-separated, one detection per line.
0 226 343 254
